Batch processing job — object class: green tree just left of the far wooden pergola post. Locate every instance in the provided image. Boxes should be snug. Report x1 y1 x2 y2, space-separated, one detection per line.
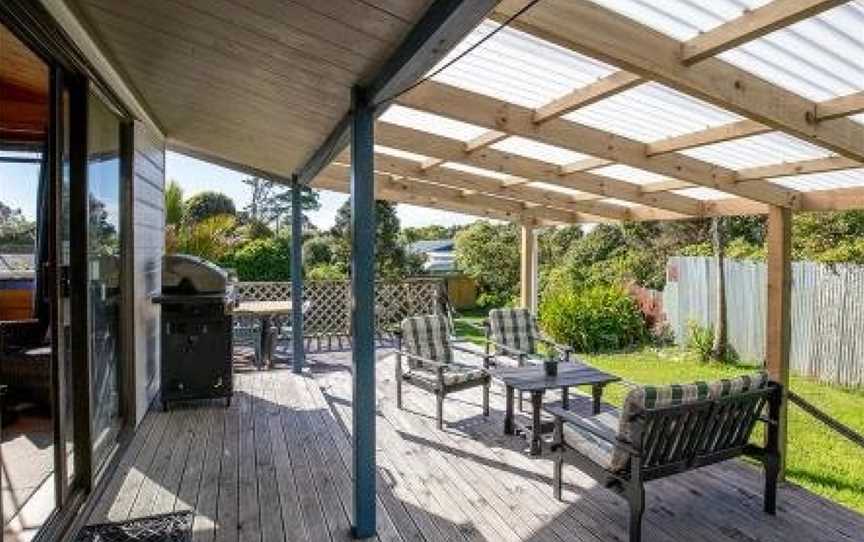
455 220 520 305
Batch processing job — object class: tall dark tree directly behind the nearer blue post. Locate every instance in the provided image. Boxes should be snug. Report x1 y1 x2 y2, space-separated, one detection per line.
330 200 409 278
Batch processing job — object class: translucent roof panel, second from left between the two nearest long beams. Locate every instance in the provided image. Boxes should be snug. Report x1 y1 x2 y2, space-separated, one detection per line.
564 83 740 143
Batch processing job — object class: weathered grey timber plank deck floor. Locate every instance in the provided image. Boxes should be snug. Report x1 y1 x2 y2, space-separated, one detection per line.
90 350 864 542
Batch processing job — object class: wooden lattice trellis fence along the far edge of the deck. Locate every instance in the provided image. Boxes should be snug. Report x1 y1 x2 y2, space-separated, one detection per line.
237 278 446 337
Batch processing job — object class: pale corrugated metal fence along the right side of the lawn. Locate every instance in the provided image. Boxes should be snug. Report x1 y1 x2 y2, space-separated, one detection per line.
663 257 864 386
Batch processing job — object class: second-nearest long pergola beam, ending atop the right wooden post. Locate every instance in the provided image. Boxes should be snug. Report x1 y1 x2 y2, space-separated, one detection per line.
400 81 795 207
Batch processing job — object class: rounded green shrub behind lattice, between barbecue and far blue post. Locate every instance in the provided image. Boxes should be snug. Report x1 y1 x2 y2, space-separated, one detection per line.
220 237 291 281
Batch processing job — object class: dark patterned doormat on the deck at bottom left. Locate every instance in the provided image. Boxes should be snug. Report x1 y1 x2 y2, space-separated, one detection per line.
75 512 195 542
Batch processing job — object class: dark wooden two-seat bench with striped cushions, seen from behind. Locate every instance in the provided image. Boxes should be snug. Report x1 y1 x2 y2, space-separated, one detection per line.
546 373 782 542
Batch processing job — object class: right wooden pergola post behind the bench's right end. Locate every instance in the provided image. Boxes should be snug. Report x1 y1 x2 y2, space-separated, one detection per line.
765 205 792 480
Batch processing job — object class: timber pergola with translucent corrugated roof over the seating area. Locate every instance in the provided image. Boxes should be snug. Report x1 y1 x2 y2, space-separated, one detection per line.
298 0 864 528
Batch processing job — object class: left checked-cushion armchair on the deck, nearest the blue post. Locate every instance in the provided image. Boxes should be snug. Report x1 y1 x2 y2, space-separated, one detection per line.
396 315 490 429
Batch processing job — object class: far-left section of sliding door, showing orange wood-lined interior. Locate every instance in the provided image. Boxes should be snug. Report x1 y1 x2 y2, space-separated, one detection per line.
0 20 56 541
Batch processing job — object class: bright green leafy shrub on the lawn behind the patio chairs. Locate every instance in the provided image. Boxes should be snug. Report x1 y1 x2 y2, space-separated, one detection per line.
540 280 648 352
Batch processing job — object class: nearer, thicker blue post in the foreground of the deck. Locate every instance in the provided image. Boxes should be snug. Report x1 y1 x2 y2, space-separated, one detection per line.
351 87 376 538
